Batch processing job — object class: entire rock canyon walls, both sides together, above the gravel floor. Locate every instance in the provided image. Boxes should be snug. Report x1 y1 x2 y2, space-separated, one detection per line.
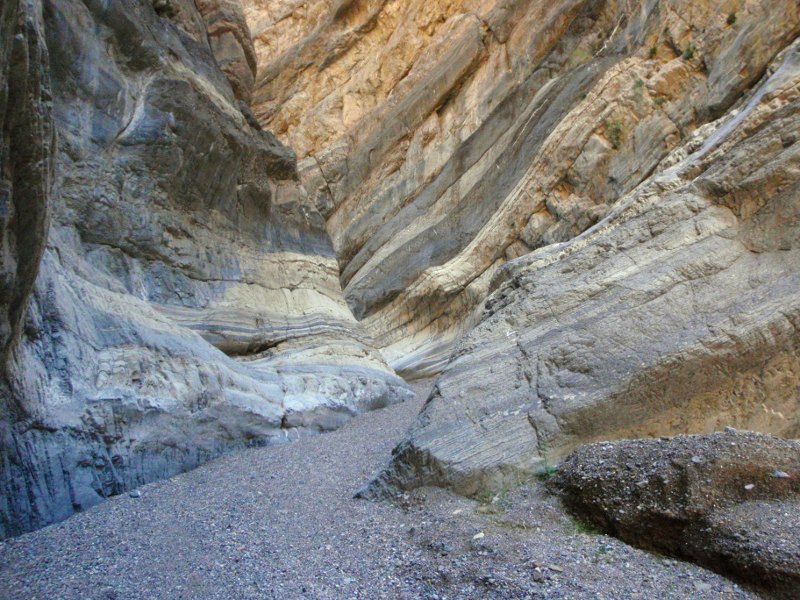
0 0 800 537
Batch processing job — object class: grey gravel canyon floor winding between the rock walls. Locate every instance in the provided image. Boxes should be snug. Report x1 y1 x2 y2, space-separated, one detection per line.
0 381 758 599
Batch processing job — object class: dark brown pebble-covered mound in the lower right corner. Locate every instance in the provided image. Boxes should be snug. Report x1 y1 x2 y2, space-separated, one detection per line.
553 431 800 598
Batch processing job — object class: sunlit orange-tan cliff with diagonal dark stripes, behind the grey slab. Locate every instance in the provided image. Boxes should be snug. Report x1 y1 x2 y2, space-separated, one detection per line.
250 0 798 376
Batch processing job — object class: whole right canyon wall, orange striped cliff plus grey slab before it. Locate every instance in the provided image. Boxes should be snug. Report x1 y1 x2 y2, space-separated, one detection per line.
245 0 800 495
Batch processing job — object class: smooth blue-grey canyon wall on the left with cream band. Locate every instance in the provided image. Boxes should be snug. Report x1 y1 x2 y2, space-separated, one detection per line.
0 0 410 537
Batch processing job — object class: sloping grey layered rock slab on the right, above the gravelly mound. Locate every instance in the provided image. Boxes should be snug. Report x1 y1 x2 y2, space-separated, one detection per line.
367 36 800 494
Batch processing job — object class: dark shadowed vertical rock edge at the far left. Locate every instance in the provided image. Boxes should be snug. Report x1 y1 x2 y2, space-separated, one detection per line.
0 0 55 376
